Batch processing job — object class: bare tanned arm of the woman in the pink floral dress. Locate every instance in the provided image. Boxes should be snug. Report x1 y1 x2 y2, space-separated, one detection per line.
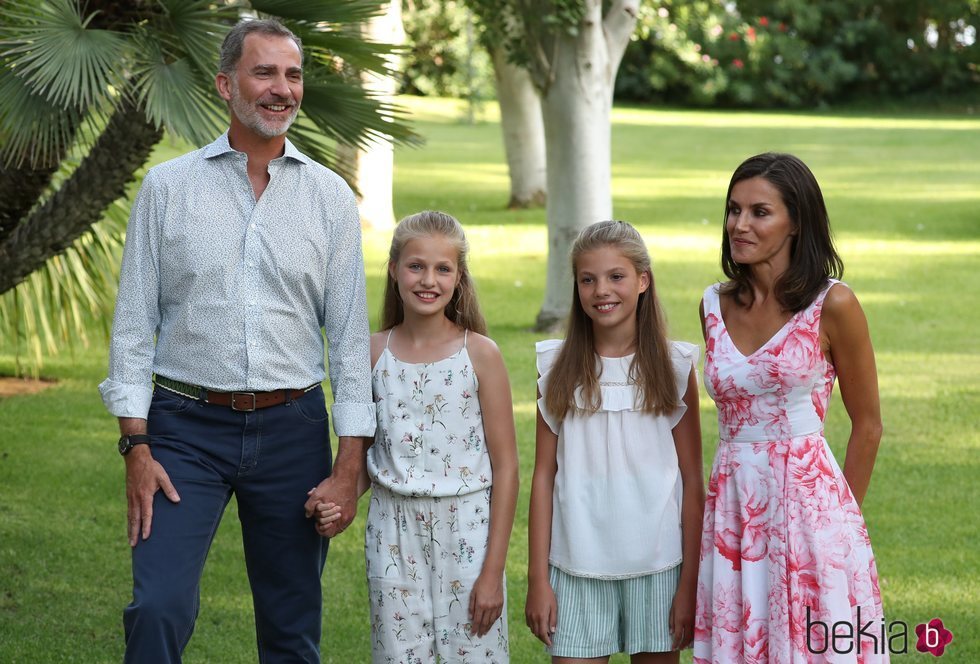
820 285 882 505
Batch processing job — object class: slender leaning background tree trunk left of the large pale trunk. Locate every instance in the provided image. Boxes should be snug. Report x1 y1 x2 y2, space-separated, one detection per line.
490 45 547 210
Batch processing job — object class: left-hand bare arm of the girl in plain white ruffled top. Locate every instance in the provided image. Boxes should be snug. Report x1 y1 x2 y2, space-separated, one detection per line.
524 394 558 646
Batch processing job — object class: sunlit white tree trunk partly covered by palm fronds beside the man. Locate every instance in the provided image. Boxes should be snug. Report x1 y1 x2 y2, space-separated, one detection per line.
337 0 405 228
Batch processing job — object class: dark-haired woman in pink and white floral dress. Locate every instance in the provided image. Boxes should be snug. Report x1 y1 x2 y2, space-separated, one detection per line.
694 153 888 664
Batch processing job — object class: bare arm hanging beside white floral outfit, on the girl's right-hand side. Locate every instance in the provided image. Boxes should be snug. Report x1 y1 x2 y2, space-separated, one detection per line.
469 334 519 636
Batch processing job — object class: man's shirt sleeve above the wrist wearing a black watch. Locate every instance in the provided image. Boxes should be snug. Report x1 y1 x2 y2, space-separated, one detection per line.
99 170 161 419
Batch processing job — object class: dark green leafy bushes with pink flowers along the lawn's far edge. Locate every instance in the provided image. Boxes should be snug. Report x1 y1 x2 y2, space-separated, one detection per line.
617 0 980 106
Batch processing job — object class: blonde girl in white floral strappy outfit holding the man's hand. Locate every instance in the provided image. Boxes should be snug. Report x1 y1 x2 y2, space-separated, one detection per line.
320 212 518 664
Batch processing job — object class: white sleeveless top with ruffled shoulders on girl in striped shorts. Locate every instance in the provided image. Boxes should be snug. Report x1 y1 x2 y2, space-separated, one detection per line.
536 339 698 579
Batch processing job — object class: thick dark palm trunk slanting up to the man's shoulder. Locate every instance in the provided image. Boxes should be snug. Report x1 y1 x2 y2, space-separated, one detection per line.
0 101 163 293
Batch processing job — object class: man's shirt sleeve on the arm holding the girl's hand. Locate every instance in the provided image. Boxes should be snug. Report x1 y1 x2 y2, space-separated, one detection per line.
323 184 377 436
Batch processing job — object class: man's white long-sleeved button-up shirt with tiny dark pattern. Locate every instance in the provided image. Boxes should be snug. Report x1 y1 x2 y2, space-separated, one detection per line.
99 133 375 436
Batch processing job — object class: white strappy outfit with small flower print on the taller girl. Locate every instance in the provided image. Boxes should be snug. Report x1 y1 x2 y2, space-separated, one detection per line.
364 333 509 664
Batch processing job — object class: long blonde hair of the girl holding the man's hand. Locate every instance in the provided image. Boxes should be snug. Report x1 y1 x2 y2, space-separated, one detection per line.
381 210 487 334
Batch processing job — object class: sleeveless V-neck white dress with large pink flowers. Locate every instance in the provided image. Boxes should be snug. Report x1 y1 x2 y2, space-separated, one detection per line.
694 280 888 664
